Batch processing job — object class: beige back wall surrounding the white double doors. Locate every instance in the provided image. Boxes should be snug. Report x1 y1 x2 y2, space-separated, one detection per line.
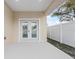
14 12 47 42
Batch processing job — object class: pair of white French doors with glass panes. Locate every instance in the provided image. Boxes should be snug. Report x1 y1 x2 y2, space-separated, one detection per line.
20 20 39 41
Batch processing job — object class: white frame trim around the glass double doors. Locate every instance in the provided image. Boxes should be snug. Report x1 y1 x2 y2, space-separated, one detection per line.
19 18 39 42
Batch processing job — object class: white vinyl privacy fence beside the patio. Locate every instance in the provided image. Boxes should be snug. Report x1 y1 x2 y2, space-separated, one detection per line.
47 21 75 47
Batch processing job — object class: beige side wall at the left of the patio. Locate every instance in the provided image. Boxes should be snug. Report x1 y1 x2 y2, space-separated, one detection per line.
4 4 14 44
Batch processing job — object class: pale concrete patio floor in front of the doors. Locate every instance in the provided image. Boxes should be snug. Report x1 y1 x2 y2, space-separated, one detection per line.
4 42 73 59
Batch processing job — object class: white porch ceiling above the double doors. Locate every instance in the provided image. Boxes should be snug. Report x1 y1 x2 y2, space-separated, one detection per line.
4 0 65 12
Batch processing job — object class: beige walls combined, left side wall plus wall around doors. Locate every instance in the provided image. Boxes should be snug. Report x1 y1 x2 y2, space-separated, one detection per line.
4 4 47 44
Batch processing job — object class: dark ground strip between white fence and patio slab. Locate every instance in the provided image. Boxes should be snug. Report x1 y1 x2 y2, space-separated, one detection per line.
47 38 75 59
